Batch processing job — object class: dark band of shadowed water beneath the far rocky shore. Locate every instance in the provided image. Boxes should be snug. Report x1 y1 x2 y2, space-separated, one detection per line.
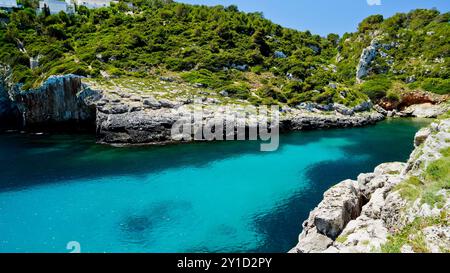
0 126 334 191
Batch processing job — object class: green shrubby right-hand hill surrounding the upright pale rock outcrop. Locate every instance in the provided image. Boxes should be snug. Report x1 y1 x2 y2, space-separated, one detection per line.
336 9 450 100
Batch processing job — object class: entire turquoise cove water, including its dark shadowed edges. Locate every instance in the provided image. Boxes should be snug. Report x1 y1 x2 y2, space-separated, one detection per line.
0 119 427 252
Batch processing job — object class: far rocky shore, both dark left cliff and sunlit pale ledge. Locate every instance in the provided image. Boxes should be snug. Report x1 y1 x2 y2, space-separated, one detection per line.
2 75 384 145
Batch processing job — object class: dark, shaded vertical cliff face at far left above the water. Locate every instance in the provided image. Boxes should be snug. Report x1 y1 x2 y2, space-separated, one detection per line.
0 75 101 130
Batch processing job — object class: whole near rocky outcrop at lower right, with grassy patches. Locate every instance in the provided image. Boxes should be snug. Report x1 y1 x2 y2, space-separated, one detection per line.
291 117 450 253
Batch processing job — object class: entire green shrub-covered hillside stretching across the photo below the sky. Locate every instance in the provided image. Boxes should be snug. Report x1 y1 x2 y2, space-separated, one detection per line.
0 0 450 105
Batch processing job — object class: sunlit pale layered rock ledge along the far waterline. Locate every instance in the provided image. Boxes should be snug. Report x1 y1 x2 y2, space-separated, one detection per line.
96 90 384 144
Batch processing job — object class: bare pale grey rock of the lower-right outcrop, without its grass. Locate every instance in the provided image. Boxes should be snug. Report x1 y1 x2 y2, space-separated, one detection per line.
290 119 450 253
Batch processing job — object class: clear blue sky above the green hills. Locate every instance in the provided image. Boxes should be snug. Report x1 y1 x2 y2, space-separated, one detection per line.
176 0 450 35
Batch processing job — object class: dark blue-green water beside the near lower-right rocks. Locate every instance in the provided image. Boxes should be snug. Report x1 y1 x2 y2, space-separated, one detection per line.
253 120 429 253
